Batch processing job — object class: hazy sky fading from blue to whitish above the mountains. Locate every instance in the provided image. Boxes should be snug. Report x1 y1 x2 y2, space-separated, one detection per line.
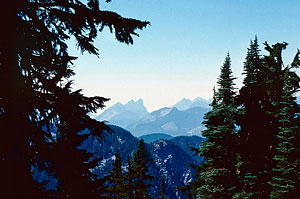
70 0 300 111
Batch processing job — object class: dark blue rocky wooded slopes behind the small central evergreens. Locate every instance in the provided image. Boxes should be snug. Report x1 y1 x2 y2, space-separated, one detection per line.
81 126 202 199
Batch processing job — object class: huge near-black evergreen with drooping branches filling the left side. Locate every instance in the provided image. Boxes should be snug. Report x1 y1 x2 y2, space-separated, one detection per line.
0 0 148 198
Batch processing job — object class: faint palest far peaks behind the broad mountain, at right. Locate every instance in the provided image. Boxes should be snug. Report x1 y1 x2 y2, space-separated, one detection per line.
173 97 212 111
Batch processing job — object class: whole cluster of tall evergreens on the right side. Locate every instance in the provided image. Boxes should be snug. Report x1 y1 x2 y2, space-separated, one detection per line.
182 38 300 199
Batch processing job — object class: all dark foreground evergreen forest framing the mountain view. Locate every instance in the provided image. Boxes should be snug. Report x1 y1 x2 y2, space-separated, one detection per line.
0 0 300 199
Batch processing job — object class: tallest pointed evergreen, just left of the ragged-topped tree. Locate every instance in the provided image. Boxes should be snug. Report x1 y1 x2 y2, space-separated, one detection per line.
236 37 269 198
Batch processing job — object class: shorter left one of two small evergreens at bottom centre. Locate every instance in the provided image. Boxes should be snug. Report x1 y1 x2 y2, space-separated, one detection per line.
106 151 127 199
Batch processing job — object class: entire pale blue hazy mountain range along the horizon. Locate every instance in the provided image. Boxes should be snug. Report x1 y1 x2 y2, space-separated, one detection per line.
95 97 211 137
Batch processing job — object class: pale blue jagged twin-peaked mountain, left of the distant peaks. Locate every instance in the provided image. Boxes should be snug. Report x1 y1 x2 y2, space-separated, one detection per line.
95 99 148 127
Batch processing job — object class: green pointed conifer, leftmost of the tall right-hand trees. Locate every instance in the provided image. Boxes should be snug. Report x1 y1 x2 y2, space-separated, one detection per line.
196 54 236 198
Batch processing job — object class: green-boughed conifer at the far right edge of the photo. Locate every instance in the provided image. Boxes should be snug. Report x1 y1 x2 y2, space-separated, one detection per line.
270 50 300 199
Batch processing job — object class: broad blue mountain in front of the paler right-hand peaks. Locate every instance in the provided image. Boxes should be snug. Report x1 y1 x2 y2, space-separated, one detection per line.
126 107 210 137
